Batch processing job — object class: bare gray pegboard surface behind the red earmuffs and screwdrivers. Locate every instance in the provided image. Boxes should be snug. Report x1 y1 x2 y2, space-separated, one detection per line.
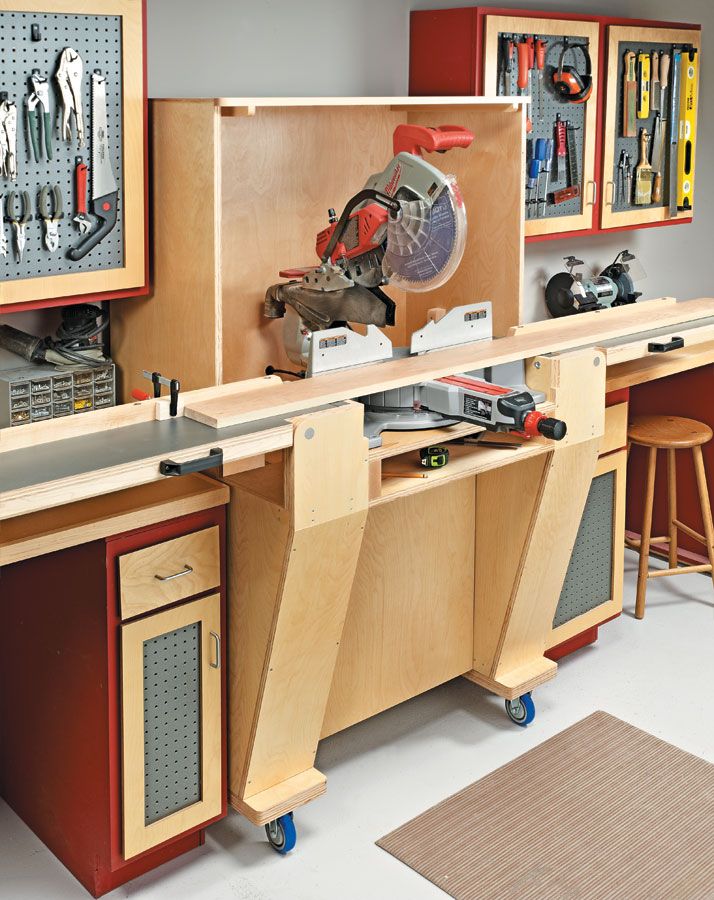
497 33 591 219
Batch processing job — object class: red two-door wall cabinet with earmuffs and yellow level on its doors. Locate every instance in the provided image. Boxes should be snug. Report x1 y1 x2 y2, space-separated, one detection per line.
409 7 700 241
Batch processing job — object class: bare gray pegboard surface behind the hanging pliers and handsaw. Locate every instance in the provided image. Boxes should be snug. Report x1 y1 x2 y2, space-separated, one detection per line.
0 12 124 280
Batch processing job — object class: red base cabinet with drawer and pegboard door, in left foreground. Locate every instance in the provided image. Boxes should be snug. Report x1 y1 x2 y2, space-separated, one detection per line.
0 496 226 896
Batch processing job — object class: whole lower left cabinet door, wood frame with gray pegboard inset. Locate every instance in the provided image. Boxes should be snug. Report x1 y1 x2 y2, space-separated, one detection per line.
121 594 222 859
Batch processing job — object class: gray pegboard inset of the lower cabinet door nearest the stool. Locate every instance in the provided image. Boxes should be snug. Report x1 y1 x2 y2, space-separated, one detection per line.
553 472 615 628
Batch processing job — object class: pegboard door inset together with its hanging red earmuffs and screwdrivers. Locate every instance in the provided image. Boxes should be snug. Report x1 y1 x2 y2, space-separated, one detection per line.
497 33 592 219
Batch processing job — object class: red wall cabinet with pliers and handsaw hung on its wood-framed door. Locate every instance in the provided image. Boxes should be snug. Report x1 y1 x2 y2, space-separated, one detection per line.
0 0 147 312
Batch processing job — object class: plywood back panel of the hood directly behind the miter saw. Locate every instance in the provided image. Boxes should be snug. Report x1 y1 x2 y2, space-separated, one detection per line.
221 106 405 381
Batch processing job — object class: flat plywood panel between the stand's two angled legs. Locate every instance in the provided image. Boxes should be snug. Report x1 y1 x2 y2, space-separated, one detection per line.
322 478 475 737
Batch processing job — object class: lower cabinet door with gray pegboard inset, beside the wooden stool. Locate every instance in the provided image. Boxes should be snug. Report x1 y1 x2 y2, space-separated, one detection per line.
548 449 627 647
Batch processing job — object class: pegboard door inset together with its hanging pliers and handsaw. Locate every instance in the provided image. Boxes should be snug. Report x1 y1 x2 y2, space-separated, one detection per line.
0 11 124 281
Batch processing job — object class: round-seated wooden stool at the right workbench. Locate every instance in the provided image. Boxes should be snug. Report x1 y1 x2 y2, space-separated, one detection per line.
626 416 714 619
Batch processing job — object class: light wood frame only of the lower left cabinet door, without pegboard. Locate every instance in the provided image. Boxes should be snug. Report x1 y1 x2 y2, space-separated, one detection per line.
121 594 223 859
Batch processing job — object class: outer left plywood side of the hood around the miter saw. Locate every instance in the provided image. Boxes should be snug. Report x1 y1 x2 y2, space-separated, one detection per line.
111 100 218 401
